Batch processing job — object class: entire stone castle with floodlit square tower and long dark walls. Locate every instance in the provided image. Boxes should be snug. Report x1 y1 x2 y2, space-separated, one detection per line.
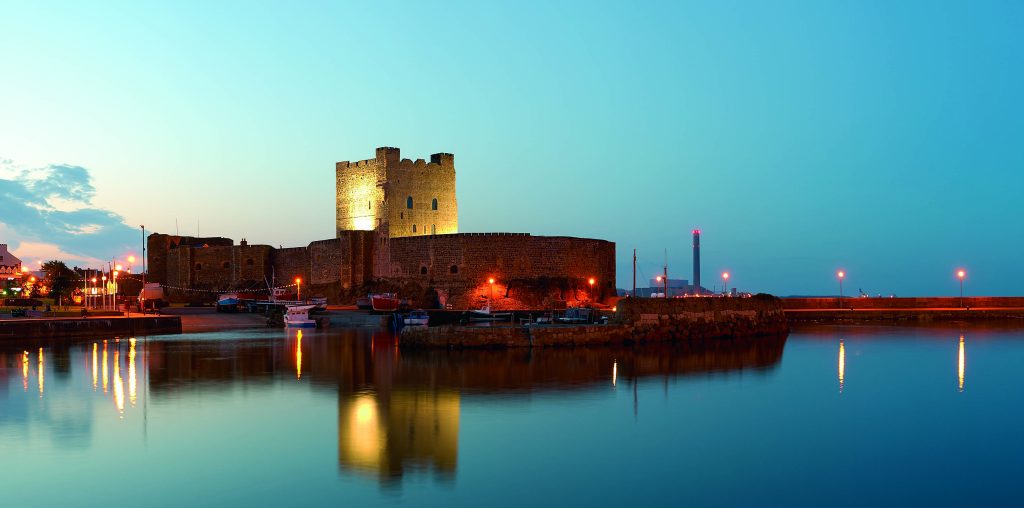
147 147 615 308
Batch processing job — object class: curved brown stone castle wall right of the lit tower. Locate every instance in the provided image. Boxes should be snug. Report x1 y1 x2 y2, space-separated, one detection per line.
385 234 615 308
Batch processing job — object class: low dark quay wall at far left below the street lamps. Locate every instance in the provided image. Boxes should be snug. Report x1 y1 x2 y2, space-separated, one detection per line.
0 315 181 341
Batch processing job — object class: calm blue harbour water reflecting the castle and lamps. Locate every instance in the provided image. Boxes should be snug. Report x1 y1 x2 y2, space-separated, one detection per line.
0 327 1024 507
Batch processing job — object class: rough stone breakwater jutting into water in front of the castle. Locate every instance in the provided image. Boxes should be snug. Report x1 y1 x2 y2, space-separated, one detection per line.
399 295 788 348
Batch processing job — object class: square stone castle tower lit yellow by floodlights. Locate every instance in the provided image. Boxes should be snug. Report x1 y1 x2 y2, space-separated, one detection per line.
335 146 459 238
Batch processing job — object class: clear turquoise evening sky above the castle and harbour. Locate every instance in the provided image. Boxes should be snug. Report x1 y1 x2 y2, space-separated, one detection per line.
0 0 1024 296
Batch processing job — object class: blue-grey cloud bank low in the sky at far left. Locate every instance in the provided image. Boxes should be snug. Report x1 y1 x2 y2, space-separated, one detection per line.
0 159 139 262
